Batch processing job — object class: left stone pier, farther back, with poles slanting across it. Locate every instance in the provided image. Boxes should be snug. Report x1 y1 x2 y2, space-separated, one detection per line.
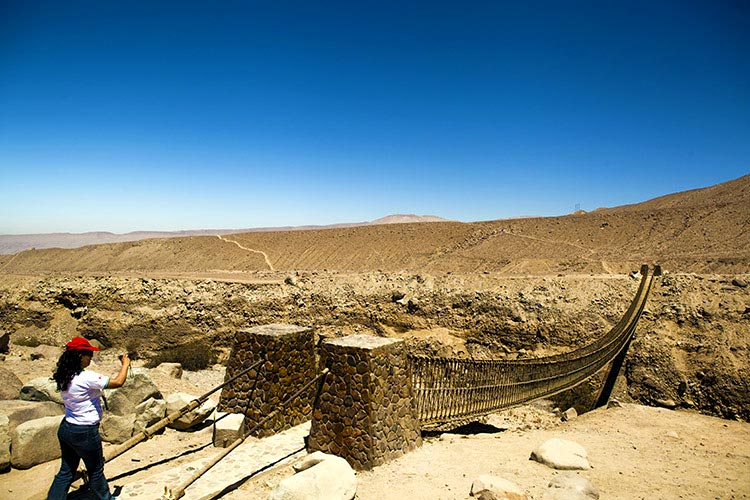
218 324 317 437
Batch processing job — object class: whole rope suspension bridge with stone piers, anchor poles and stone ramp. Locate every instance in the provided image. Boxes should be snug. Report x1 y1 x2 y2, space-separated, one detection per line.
91 265 661 500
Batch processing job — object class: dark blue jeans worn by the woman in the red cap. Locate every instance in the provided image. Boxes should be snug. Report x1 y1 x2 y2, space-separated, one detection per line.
47 419 112 500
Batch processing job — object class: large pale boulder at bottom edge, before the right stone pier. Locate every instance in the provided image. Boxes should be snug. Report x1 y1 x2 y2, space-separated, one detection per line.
268 451 357 500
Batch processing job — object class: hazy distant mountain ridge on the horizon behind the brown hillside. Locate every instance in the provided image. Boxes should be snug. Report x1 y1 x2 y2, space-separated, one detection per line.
0 214 449 254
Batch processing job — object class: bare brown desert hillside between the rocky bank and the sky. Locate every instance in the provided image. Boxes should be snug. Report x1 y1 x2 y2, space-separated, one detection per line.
0 175 750 275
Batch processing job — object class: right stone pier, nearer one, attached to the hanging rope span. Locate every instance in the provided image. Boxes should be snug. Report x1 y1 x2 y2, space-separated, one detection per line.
308 335 422 470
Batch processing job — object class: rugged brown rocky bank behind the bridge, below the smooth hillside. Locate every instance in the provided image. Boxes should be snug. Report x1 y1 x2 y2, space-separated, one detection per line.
0 269 750 420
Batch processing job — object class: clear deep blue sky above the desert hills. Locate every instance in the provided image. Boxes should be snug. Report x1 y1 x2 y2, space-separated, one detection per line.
0 0 750 234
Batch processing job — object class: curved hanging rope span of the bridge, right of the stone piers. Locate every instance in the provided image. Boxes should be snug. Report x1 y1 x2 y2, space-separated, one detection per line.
409 265 661 428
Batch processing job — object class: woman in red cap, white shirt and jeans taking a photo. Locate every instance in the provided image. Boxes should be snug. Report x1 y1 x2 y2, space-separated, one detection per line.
47 337 130 500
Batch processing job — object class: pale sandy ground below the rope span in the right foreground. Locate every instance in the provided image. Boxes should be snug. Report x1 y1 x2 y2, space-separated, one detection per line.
227 404 750 500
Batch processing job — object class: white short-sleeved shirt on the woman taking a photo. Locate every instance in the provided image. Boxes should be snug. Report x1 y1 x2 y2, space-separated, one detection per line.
60 370 109 425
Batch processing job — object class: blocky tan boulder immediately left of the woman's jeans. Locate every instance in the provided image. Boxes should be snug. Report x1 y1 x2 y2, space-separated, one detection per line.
10 417 62 469
